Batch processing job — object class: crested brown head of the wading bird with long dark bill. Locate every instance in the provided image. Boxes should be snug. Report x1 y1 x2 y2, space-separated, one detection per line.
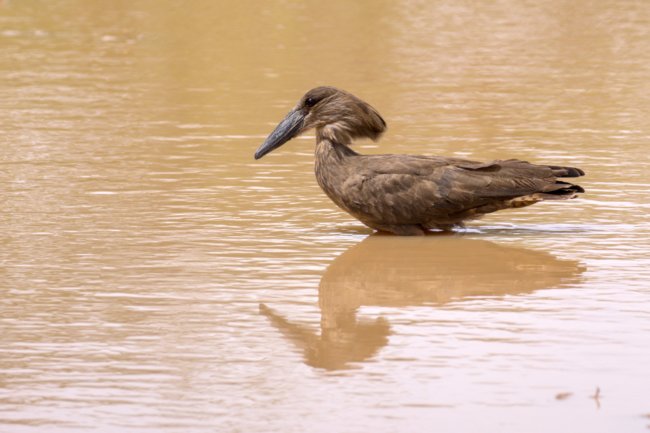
255 86 386 159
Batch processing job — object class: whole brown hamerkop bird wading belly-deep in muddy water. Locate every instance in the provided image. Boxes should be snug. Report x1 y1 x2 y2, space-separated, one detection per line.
255 87 584 235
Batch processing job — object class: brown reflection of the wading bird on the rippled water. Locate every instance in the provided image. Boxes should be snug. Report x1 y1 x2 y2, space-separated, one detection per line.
260 235 584 370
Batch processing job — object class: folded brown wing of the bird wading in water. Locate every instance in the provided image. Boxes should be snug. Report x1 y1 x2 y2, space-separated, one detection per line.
343 155 580 224
